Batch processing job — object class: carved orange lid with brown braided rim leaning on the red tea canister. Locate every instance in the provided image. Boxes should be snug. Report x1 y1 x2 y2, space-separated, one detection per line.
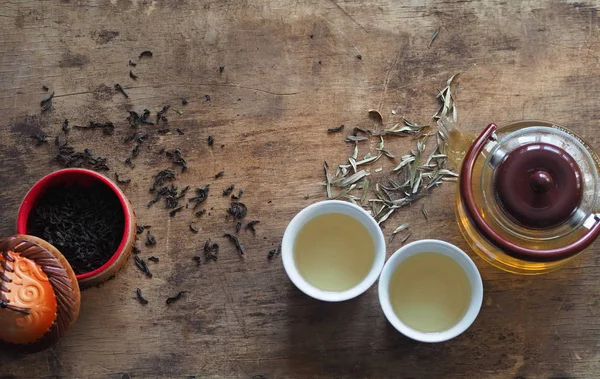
0 235 80 351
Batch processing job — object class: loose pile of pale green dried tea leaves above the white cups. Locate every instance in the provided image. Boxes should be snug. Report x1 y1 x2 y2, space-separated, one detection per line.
323 75 457 227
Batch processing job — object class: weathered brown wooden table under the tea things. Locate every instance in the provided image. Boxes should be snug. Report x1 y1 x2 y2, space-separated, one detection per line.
0 0 600 379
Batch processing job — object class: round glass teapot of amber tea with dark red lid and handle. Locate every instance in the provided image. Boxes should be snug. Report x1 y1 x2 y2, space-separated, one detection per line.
449 121 600 275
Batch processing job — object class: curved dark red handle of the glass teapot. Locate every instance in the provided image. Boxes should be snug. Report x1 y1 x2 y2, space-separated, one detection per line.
459 123 600 262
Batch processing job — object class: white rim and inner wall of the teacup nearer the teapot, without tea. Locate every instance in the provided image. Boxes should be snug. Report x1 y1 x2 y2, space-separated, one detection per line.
379 240 483 342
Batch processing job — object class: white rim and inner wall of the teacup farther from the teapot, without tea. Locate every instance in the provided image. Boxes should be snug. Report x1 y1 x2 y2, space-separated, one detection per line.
281 200 386 302
